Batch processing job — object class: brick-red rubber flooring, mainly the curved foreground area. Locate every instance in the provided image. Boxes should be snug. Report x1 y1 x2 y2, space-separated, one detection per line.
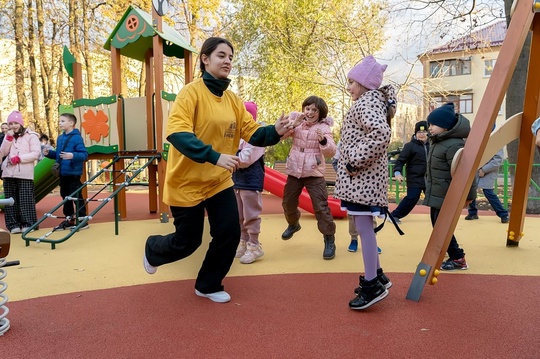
0 191 540 359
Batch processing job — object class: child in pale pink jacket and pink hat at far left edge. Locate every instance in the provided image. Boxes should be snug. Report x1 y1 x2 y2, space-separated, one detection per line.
0 111 41 234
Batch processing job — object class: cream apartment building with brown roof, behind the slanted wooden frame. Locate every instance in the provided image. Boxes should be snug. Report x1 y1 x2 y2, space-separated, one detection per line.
419 20 506 123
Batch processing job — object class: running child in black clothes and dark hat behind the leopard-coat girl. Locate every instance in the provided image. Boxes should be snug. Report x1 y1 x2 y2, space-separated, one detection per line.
392 121 429 223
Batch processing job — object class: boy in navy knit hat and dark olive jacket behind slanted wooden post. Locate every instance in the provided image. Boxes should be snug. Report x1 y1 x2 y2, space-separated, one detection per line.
424 102 470 270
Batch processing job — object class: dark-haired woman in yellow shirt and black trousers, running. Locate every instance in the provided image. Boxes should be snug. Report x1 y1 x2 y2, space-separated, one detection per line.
144 37 290 303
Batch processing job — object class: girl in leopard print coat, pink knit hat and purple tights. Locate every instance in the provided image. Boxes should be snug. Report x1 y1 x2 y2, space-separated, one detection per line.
334 56 396 310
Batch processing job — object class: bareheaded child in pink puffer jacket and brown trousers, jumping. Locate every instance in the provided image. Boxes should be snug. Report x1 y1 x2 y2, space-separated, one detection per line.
281 96 336 259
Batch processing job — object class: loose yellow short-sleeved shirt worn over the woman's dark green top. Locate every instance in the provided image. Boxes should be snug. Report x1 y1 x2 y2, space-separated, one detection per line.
163 78 260 207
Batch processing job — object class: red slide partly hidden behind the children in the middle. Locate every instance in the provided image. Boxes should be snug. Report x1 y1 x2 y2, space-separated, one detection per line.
264 167 347 218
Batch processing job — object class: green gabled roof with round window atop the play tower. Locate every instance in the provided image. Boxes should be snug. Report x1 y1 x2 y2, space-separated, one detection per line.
103 5 197 61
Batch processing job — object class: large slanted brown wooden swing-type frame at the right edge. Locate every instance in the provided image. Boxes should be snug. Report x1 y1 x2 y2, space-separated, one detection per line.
407 0 540 301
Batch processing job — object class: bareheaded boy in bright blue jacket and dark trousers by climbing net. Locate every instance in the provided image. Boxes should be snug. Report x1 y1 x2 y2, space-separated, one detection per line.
43 113 88 231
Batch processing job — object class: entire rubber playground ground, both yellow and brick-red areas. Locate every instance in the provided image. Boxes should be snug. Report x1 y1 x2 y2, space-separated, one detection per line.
0 189 540 359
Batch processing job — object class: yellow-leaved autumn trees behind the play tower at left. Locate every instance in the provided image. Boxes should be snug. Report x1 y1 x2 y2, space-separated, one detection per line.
0 0 224 143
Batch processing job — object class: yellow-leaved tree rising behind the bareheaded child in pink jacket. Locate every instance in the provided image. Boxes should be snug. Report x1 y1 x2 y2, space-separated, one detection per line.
225 0 386 162
